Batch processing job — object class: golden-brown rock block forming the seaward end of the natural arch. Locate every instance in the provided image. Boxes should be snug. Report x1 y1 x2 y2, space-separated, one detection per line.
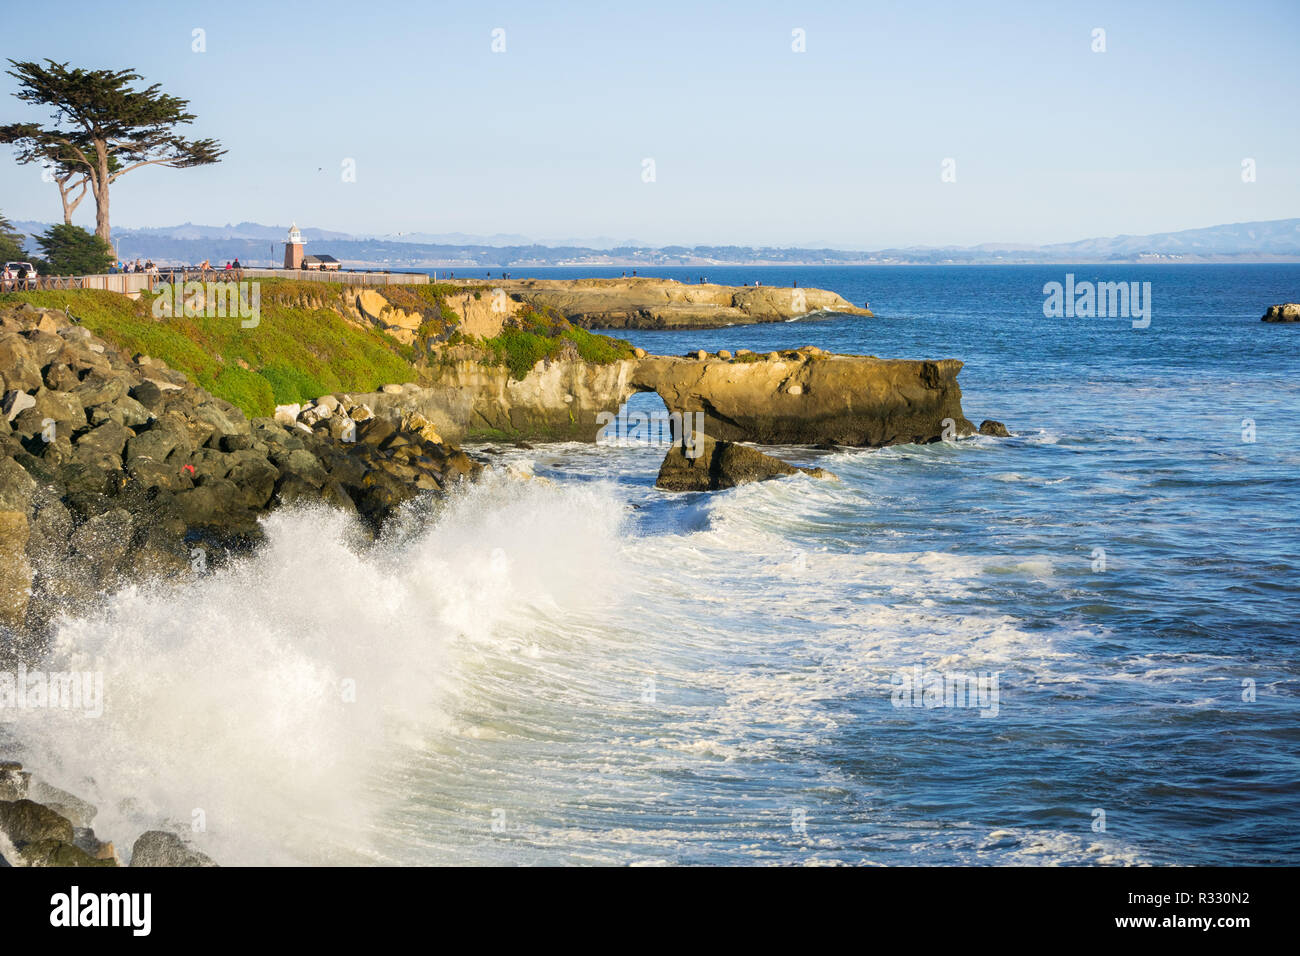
631 349 975 446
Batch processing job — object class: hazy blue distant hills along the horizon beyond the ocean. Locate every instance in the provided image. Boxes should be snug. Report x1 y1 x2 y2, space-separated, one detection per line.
14 219 1300 269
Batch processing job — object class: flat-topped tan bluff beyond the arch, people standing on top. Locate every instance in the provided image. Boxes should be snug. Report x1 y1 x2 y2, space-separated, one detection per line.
439 277 871 329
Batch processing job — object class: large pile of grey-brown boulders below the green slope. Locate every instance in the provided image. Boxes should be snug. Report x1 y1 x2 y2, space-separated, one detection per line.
0 306 481 634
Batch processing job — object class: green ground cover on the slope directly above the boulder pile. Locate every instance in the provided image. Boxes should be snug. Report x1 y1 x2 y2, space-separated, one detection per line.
0 280 416 415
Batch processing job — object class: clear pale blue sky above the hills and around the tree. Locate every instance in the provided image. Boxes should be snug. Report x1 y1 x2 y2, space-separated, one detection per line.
0 0 1300 248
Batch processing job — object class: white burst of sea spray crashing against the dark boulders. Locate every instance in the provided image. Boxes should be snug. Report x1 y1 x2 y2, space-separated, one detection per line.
10 477 624 864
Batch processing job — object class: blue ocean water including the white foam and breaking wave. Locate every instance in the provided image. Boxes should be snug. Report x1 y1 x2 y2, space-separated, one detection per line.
8 265 1300 865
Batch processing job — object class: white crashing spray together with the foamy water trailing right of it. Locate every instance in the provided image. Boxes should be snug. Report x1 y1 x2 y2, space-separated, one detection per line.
5 449 1180 864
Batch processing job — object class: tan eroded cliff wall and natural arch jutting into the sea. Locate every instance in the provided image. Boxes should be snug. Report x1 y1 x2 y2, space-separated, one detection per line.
359 349 975 446
